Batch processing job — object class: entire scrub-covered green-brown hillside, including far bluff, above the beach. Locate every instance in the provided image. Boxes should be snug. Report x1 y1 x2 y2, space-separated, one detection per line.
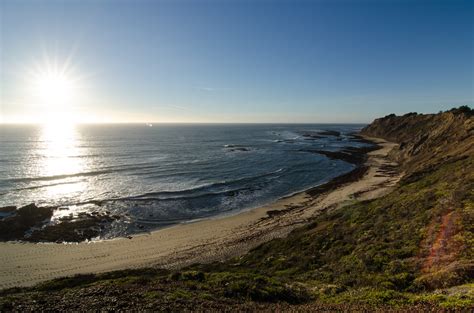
0 107 474 310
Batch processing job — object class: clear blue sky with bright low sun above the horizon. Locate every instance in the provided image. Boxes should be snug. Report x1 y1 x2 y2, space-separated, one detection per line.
0 0 474 123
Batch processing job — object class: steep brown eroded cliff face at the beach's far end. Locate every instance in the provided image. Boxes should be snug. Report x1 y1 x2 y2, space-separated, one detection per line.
361 108 474 174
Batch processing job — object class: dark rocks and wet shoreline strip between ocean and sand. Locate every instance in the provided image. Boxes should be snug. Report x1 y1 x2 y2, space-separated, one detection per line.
0 132 379 244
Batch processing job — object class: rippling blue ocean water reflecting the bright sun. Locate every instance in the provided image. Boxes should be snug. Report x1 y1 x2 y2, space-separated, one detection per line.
0 124 363 238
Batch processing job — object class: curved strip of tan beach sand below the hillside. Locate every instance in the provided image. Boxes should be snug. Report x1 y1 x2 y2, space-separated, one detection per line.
0 138 401 289
